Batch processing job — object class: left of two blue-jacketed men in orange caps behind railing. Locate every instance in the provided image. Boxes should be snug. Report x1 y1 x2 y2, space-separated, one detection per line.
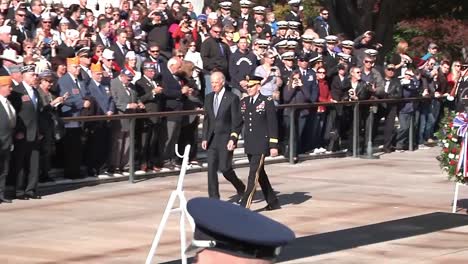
57 57 91 179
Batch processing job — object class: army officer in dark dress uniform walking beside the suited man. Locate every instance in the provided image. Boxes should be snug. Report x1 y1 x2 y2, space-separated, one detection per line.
241 75 281 210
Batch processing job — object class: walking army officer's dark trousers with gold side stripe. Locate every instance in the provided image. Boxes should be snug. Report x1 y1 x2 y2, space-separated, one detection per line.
241 154 278 208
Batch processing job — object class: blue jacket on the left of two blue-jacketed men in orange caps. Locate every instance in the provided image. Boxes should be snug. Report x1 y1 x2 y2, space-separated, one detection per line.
57 74 90 127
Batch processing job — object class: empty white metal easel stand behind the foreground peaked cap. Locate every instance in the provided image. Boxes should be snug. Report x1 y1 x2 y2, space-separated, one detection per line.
145 144 195 264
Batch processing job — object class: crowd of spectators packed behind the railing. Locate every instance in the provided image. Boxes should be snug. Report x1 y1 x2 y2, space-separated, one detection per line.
0 0 467 202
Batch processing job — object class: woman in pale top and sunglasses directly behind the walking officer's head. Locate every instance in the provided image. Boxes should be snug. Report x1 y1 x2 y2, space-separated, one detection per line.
254 50 283 104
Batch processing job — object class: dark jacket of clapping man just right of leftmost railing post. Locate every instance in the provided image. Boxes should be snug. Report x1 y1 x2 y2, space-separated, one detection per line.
135 76 164 124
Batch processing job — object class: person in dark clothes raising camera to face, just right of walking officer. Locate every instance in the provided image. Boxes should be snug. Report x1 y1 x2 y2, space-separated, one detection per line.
282 70 310 160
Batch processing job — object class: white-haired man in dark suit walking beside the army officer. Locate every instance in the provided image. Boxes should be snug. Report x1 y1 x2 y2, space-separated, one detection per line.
202 72 245 199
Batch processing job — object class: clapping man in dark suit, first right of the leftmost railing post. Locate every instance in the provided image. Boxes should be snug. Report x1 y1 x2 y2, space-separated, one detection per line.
135 61 164 172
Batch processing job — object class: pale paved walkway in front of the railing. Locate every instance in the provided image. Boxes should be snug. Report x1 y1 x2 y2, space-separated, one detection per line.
0 148 468 264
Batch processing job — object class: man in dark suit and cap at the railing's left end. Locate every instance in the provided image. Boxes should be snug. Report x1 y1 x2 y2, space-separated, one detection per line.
9 65 42 199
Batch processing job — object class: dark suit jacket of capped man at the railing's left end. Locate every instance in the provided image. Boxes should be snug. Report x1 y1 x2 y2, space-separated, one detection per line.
9 83 42 142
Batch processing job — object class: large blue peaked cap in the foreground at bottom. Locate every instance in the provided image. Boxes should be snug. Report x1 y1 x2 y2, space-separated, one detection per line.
187 197 295 260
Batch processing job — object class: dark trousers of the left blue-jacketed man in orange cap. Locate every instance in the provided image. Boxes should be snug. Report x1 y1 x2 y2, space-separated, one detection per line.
63 127 83 179
